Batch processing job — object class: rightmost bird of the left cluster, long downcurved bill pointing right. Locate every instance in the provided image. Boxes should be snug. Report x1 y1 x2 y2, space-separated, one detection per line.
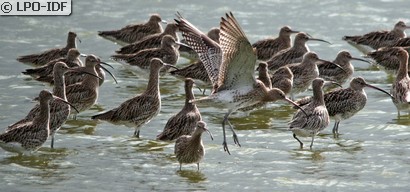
66 55 102 118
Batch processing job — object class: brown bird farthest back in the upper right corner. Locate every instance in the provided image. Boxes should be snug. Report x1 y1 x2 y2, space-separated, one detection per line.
342 21 410 49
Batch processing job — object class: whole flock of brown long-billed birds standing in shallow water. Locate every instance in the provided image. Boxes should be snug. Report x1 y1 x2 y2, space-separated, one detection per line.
0 13 410 170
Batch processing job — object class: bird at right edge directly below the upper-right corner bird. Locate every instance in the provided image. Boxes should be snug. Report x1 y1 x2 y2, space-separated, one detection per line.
365 46 410 73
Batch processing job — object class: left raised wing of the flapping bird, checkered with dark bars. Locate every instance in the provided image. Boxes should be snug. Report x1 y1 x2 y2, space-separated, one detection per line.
175 14 222 85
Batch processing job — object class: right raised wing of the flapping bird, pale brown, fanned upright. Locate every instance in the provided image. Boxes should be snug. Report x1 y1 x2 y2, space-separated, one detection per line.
218 13 256 89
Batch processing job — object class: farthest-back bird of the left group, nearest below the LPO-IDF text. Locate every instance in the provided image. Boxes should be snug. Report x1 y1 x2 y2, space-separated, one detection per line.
17 31 77 66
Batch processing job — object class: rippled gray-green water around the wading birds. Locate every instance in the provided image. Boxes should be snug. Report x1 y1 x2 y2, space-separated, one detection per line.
0 0 410 191
